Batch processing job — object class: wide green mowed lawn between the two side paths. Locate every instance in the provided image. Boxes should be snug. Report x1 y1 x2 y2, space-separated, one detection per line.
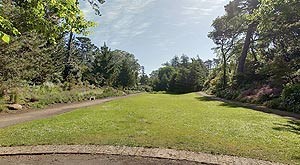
0 93 300 164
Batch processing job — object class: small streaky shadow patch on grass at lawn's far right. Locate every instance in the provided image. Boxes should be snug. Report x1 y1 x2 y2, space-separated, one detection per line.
273 120 300 135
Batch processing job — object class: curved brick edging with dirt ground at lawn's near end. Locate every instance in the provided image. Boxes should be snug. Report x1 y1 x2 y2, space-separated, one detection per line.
0 145 279 165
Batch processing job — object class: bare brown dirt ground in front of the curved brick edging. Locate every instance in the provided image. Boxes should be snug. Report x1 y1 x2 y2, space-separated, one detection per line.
0 154 201 165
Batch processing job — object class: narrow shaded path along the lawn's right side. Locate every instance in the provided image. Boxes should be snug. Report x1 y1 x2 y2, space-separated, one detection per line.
198 92 300 120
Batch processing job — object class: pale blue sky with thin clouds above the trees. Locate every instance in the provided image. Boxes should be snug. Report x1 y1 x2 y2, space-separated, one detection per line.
81 0 229 73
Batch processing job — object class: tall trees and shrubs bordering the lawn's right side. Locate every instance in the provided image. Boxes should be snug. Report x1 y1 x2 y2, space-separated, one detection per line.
205 0 300 112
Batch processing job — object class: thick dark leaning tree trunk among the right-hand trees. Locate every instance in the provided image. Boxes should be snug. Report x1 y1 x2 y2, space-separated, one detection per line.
237 23 256 74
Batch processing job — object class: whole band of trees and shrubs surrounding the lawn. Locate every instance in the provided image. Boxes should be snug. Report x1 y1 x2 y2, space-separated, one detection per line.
0 0 300 112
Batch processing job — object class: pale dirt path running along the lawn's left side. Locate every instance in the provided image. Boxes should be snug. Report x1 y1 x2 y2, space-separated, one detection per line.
0 95 133 128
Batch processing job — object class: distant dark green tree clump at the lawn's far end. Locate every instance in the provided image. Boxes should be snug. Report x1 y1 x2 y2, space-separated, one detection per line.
150 55 208 93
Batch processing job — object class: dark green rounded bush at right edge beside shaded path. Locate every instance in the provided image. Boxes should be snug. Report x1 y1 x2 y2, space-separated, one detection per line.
282 83 300 113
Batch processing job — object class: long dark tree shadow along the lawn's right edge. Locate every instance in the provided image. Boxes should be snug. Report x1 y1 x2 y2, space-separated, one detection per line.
196 96 300 119
